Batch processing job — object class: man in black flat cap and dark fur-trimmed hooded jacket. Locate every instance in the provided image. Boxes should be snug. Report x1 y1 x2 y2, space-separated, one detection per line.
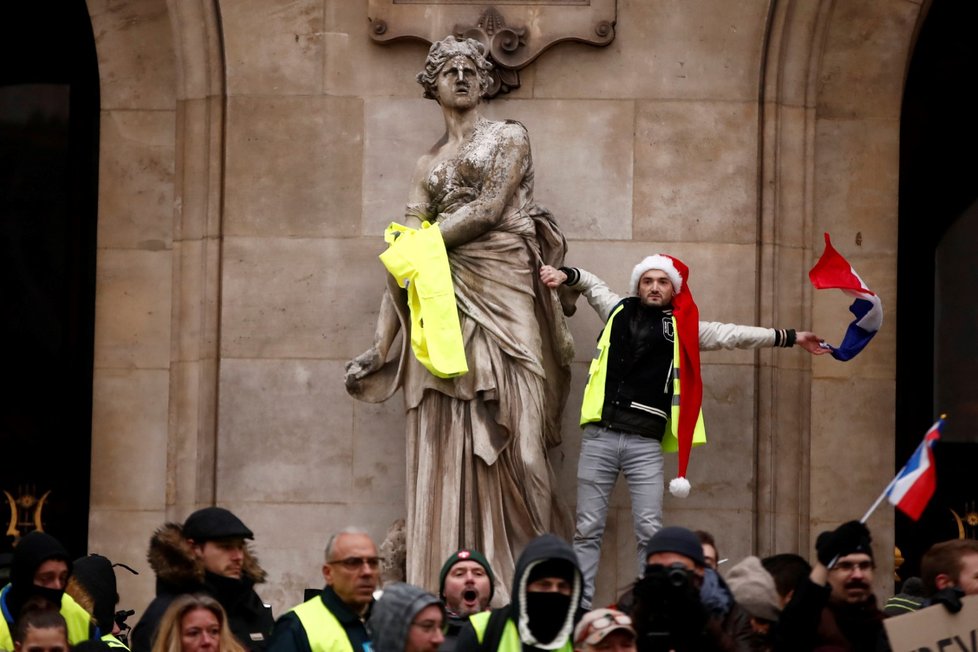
130 507 275 652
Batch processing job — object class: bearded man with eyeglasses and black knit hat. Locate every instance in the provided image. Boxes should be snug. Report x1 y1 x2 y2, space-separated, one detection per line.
775 521 889 652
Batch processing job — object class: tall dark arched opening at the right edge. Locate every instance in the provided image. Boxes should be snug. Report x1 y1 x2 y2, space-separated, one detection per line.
896 0 978 577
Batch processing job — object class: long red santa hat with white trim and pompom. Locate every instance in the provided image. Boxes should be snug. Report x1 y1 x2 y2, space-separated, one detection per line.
631 254 703 498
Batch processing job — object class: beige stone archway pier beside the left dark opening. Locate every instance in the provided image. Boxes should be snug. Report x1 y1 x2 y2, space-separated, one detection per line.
88 0 224 605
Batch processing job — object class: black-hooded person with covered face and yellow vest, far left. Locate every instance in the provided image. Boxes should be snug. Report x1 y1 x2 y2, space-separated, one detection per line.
0 531 92 650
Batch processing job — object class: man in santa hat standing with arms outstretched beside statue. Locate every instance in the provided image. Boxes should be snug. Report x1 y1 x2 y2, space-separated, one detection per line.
540 254 829 608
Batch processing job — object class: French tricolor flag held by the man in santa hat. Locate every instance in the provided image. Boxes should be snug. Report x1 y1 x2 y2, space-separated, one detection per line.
808 233 883 362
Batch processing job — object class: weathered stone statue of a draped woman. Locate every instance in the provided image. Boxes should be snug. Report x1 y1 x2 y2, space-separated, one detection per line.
346 36 573 603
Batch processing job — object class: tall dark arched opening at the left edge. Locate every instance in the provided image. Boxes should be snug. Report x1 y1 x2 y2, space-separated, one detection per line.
0 0 99 556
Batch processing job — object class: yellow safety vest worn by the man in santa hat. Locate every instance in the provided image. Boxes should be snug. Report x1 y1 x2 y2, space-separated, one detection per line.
581 305 706 453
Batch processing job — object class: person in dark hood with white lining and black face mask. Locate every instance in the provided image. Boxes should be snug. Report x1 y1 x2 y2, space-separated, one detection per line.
455 534 583 652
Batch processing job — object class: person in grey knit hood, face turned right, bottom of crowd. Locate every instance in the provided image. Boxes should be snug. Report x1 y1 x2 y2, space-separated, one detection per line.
367 582 445 652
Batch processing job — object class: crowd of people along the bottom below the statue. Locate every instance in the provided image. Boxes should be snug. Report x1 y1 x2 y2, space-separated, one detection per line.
0 507 978 652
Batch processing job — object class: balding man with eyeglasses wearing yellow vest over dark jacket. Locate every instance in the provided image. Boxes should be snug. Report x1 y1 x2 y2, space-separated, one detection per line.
268 528 383 652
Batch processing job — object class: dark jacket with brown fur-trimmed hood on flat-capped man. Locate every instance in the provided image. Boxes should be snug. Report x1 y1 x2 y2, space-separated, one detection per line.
130 523 275 652
